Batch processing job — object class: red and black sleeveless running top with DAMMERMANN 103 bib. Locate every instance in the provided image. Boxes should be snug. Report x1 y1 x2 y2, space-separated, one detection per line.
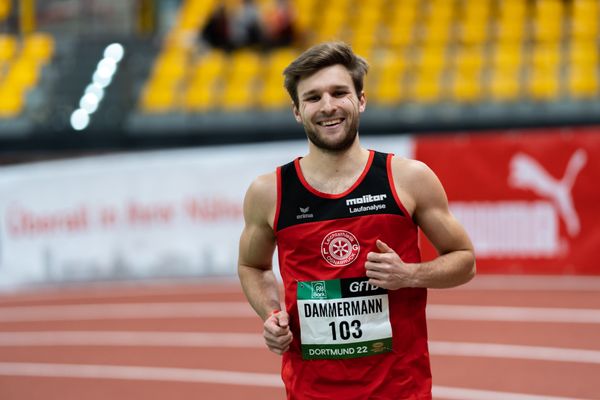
274 151 431 400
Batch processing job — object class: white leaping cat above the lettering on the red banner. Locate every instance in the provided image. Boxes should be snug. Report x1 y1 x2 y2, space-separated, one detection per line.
508 149 587 237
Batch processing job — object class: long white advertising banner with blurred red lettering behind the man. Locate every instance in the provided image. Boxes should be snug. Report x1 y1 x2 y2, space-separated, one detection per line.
0 137 412 288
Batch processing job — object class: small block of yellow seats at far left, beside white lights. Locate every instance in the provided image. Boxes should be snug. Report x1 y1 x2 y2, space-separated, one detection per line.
0 33 54 118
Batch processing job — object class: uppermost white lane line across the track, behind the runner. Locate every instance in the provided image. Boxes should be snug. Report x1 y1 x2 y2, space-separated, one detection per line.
0 302 600 324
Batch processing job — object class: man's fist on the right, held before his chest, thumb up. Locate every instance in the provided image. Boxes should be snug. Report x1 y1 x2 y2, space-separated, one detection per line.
365 240 414 290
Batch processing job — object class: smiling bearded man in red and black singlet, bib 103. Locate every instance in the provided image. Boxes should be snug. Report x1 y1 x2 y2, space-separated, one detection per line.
238 42 475 400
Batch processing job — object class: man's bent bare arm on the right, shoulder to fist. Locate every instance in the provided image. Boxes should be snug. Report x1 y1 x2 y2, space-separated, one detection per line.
365 158 475 289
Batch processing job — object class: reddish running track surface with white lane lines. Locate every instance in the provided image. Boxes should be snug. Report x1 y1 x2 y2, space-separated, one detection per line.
0 277 600 400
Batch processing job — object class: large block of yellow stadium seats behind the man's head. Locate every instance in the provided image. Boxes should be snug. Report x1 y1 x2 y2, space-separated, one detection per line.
140 0 600 113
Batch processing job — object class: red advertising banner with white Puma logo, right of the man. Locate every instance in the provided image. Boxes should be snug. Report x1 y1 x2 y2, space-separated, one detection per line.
415 127 600 275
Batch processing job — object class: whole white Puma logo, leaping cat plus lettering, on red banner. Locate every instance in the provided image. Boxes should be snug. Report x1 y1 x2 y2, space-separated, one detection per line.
450 149 587 258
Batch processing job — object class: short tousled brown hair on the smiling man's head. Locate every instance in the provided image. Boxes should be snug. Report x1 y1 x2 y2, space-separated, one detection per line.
283 42 369 107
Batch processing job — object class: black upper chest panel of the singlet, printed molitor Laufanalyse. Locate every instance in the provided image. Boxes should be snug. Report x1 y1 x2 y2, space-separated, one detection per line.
277 152 404 230
